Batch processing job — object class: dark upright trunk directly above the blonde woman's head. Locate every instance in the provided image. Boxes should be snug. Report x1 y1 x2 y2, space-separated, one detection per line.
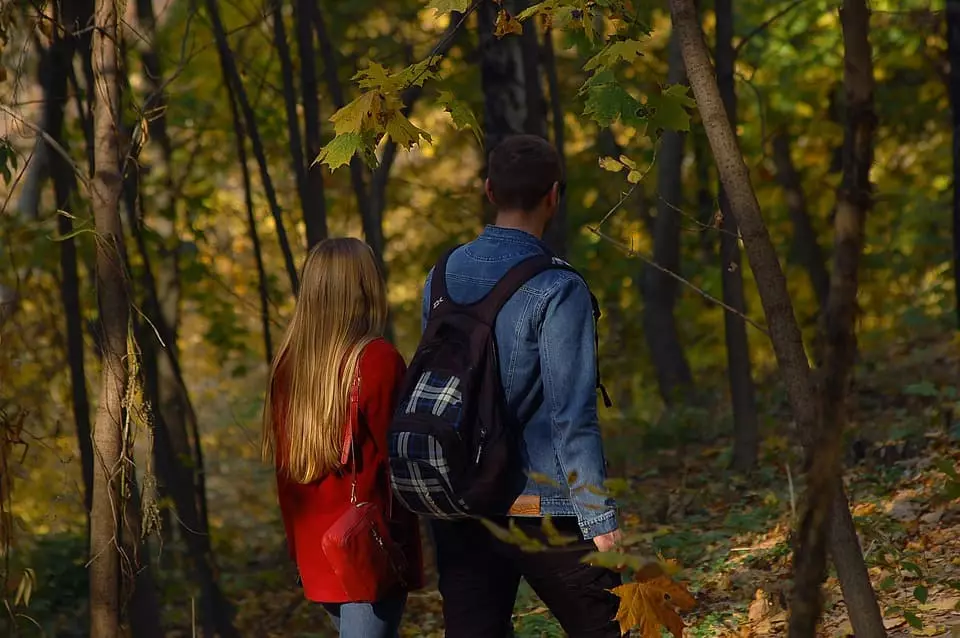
294 0 327 249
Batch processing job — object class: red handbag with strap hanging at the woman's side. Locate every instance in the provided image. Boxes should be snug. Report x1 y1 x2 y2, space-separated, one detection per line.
321 366 403 602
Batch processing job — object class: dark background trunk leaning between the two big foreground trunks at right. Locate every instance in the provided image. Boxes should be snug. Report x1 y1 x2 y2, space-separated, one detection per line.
772 133 830 310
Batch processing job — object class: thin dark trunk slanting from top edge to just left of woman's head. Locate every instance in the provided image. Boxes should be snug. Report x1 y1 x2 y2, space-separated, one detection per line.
205 0 300 296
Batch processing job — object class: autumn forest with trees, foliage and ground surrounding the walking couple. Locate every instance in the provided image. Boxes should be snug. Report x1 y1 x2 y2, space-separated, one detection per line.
0 0 960 637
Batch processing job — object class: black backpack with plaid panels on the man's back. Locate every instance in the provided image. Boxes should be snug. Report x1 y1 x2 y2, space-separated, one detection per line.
387 247 610 519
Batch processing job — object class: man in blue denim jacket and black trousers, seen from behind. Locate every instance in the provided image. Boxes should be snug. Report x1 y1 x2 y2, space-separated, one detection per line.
423 135 621 638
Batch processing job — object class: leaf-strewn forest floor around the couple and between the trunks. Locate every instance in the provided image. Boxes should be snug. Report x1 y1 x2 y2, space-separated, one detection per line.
20 337 960 638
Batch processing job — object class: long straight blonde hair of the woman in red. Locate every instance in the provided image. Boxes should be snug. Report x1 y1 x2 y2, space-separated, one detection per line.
261 237 387 483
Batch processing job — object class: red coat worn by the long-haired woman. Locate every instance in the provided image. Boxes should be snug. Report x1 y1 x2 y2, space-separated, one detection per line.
274 339 423 603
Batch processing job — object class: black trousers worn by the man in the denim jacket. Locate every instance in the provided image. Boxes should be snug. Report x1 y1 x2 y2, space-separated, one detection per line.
432 517 621 638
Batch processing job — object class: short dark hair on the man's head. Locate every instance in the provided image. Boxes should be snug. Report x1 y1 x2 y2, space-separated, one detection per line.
487 135 563 211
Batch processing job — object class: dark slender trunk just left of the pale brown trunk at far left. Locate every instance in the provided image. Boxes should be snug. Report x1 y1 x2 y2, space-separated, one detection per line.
41 15 93 525
